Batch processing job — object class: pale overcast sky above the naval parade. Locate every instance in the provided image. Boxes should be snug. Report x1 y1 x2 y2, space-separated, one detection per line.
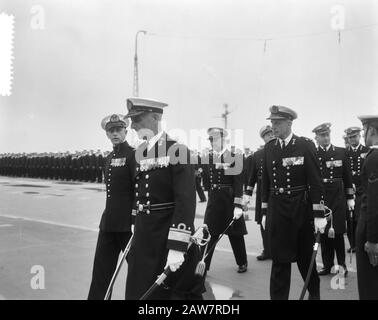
0 0 378 152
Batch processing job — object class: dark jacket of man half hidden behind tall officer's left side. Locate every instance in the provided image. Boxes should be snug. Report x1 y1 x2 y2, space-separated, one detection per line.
245 148 264 224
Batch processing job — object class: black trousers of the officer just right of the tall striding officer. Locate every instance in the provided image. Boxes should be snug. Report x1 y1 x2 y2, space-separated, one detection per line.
320 234 345 269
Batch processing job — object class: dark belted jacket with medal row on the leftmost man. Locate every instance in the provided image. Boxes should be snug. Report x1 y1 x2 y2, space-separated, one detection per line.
100 141 135 232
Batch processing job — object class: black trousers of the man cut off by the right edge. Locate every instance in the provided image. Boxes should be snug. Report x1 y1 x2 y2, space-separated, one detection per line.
356 218 378 300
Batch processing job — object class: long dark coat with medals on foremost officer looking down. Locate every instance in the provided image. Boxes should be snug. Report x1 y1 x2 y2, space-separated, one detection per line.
126 133 203 300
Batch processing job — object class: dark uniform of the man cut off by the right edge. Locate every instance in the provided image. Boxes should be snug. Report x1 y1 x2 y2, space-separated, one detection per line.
356 148 378 300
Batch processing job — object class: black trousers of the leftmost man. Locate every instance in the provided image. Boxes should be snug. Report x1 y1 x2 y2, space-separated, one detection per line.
88 230 131 300
